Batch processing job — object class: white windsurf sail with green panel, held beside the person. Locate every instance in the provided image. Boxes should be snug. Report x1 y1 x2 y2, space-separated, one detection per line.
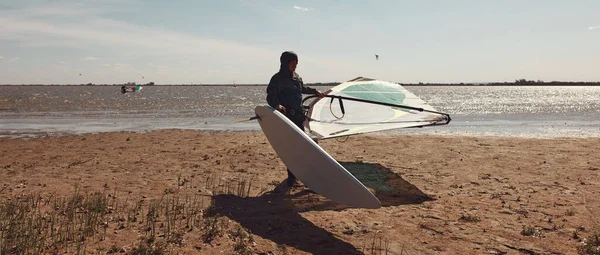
304 77 451 139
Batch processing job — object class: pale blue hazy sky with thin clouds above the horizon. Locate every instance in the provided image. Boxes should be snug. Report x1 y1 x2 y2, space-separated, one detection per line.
0 0 600 84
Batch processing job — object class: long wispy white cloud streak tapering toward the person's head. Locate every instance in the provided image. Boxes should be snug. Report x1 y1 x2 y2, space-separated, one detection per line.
0 5 278 60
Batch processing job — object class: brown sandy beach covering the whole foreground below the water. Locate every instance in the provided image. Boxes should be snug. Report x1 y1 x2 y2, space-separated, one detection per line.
0 130 600 255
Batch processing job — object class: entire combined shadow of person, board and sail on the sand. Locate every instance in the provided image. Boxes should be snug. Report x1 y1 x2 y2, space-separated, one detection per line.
214 162 433 254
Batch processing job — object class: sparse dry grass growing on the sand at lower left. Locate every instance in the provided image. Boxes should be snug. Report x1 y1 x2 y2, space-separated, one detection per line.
0 176 252 254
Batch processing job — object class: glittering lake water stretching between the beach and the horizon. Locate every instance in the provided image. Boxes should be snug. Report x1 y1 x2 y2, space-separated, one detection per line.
0 86 600 138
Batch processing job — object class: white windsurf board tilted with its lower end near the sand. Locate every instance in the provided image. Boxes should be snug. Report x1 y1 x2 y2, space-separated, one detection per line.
254 106 381 208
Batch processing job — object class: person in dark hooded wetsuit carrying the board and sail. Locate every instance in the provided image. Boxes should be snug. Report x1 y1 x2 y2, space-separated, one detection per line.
267 51 323 186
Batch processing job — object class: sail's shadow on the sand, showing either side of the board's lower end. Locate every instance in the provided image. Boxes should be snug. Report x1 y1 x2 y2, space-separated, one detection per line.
290 162 435 211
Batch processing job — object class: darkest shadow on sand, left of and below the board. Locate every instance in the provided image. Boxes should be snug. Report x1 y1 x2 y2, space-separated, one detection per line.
213 187 363 254
